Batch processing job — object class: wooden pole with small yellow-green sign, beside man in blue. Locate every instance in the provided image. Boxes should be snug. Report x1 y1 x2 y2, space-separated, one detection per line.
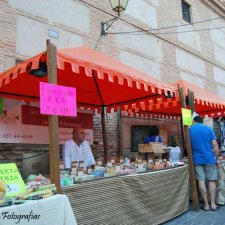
179 88 199 210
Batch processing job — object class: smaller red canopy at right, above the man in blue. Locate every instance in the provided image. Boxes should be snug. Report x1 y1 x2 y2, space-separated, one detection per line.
172 80 225 117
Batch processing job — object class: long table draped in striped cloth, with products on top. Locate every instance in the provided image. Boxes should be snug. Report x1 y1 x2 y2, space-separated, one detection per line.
61 143 189 225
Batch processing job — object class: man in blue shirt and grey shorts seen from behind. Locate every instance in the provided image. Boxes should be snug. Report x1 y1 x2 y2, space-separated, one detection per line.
190 115 219 211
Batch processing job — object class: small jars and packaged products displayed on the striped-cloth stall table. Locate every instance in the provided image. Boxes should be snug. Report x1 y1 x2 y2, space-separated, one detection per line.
60 157 182 187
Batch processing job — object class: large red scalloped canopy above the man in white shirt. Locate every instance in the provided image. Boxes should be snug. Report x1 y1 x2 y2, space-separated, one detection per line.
0 47 177 113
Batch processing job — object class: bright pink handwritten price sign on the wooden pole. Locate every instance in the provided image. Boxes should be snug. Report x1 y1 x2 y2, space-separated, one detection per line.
40 82 77 116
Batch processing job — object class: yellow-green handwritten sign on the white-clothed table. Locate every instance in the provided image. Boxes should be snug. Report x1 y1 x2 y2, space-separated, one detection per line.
0 163 26 197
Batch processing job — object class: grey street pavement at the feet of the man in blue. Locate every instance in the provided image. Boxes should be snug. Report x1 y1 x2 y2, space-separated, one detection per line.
163 205 225 225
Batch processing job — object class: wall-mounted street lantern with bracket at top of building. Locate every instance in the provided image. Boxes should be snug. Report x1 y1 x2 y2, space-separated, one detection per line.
101 0 129 36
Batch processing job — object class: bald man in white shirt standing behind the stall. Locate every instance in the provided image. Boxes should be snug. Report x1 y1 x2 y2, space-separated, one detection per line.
63 128 95 169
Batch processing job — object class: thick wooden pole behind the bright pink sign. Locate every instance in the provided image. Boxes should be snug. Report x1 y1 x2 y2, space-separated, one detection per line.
47 40 61 192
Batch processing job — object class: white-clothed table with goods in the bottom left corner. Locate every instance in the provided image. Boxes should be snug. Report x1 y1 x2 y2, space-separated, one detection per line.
0 175 77 225
